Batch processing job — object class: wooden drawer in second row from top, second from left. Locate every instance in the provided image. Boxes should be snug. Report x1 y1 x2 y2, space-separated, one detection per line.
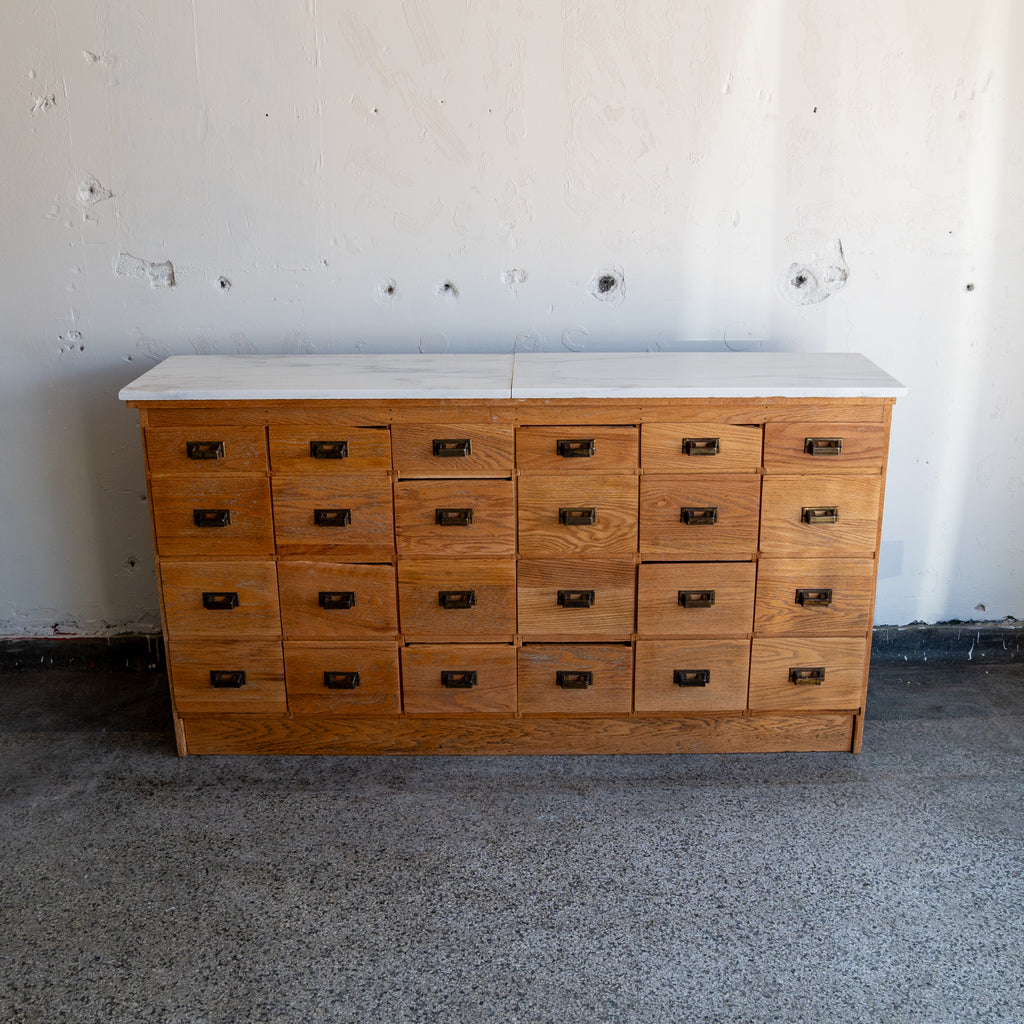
273 476 394 561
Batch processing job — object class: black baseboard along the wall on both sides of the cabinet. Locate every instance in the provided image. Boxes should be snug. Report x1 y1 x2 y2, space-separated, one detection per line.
0 620 1024 673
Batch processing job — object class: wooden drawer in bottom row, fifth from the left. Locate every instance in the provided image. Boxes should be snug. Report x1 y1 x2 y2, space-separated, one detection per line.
634 639 751 714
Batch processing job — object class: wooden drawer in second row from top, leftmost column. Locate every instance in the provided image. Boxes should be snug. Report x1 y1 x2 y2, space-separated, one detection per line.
150 476 273 558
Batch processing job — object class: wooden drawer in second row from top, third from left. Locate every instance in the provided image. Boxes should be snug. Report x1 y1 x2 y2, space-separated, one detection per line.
394 479 515 558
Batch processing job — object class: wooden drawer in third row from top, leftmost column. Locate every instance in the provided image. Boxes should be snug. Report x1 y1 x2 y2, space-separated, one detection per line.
160 559 281 639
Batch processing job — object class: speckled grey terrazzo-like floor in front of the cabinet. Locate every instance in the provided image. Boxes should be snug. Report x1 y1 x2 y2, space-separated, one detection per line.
0 659 1024 1024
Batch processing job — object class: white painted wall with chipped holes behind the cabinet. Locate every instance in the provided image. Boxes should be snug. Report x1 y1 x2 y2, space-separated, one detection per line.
0 0 1024 635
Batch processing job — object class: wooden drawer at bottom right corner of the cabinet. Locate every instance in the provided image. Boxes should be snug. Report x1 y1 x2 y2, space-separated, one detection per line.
750 637 868 711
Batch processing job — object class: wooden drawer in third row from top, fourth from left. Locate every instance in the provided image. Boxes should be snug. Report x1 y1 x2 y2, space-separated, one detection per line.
517 559 636 640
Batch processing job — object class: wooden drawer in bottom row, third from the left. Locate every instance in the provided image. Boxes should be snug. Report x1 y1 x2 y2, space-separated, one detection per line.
401 644 516 715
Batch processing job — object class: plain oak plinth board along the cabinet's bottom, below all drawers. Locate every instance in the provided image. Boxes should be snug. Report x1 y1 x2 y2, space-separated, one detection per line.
179 713 855 755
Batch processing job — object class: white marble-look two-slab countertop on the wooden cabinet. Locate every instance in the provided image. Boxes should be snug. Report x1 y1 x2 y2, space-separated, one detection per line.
119 352 906 401
